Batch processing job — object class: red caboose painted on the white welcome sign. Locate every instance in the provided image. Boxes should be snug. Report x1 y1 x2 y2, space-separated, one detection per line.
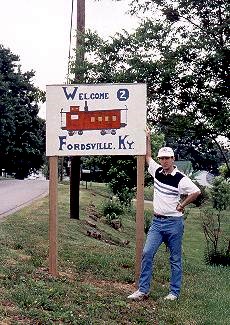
61 103 127 135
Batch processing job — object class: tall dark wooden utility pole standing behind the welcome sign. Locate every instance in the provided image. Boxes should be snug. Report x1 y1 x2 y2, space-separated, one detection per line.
70 0 85 219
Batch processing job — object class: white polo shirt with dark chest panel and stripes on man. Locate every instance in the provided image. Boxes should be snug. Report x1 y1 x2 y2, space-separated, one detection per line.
148 159 199 217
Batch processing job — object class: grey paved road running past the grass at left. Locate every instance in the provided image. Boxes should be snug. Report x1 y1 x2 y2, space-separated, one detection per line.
0 179 49 219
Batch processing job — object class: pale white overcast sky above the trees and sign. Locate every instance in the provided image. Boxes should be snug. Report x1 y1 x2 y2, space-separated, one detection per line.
0 0 137 117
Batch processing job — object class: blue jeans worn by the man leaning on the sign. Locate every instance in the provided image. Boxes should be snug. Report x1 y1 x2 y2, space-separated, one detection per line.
139 217 184 296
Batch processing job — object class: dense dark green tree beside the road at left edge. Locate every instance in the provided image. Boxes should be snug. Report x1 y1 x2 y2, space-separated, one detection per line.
0 45 45 178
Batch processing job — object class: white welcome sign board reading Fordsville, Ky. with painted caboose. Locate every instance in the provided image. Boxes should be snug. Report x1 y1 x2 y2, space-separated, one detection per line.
46 84 146 156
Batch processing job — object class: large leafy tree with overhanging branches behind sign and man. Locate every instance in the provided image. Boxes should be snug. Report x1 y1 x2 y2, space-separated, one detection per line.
70 0 230 173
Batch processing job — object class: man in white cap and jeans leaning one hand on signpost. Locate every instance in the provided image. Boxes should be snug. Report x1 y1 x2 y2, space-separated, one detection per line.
128 130 200 300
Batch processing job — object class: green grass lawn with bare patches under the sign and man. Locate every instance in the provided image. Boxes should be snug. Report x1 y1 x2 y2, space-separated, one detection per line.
0 184 230 325
